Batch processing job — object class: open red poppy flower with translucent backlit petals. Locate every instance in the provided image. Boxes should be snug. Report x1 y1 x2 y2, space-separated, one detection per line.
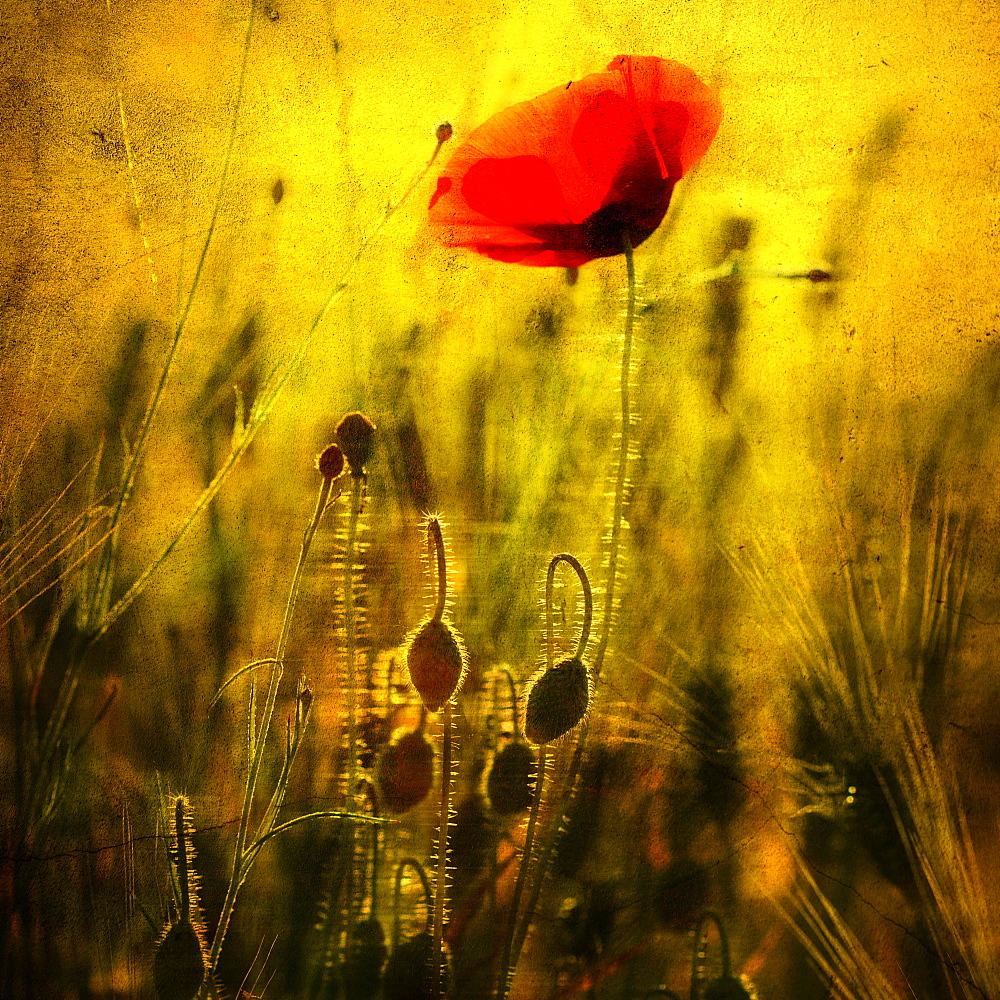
430 56 721 267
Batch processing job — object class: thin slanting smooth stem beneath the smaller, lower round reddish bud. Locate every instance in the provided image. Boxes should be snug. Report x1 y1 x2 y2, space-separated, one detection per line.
209 478 333 976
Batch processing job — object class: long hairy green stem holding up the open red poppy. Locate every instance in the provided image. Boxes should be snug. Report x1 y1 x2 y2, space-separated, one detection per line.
514 233 635 965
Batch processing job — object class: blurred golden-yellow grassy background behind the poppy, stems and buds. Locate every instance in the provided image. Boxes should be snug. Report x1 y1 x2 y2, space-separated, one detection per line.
0 0 1000 1000
